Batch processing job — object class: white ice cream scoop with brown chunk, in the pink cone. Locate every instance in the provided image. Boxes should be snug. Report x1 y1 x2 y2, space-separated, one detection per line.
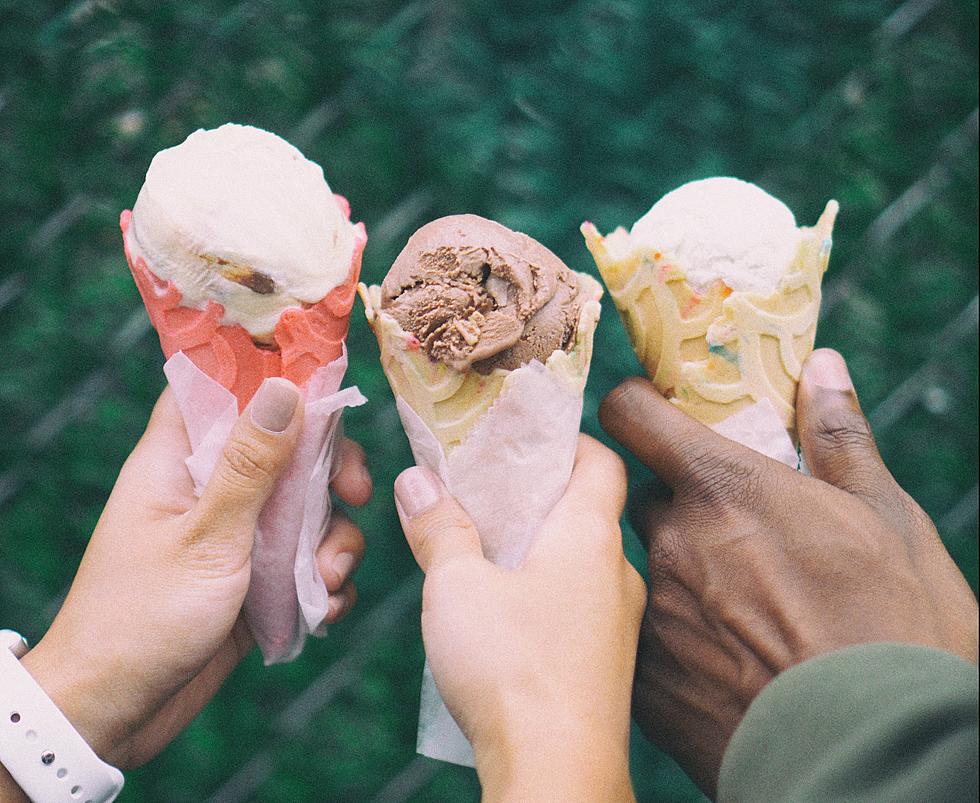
131 124 356 342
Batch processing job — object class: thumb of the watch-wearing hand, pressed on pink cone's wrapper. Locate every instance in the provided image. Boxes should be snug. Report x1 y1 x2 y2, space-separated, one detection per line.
194 378 303 545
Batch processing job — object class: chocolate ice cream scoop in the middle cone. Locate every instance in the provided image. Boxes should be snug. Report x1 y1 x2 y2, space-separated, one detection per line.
381 215 581 373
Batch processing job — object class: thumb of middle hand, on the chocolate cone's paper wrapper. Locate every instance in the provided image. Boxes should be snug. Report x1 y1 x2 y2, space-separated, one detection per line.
395 466 483 573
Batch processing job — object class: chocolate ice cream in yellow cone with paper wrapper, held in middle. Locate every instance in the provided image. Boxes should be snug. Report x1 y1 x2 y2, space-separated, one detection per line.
358 215 602 766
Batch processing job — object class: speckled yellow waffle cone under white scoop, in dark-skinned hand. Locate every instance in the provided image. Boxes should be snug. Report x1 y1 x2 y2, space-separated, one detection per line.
582 201 838 440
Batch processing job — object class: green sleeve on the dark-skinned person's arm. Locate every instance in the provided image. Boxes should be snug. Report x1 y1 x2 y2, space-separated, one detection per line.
718 644 977 803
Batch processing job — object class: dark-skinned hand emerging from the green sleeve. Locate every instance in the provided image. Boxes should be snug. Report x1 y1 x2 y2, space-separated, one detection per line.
599 350 977 794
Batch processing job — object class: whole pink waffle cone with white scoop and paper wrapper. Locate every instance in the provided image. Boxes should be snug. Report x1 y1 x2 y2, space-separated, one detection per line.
119 124 367 663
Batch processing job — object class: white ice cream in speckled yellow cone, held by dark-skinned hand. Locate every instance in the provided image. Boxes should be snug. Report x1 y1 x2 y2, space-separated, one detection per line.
582 178 838 446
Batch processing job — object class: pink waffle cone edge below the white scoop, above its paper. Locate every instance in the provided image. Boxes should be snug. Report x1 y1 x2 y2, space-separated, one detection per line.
119 200 367 410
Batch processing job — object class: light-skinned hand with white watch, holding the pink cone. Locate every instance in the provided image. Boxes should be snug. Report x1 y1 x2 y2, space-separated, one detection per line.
23 379 371 767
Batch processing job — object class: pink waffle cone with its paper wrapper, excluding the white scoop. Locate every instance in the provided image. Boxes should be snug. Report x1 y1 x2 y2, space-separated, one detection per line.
120 196 367 664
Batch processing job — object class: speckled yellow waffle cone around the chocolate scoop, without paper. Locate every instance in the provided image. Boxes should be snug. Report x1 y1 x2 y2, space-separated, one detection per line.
358 273 602 455
